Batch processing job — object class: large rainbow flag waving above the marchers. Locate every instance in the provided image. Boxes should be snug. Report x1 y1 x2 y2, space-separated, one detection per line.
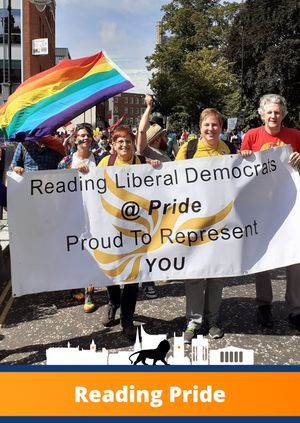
0 51 133 142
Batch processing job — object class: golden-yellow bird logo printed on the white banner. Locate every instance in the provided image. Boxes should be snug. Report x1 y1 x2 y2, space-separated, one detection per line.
94 171 233 282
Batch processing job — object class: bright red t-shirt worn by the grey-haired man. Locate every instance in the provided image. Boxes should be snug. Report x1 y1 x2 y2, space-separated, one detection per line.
241 126 300 153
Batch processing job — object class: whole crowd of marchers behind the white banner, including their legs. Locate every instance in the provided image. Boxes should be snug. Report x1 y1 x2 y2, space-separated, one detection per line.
1 94 300 343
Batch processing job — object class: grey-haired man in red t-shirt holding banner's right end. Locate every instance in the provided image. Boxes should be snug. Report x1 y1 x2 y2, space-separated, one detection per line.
241 94 300 331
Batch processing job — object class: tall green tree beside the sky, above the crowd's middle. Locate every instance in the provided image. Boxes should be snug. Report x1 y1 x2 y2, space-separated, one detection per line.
147 0 240 125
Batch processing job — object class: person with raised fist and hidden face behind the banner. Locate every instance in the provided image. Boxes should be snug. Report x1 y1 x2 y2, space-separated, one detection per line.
137 95 171 299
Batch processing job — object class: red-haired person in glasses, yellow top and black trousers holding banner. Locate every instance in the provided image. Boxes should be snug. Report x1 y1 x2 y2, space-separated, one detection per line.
98 127 161 339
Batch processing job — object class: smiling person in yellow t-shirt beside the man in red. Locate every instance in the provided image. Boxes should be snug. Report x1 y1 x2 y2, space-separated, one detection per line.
176 108 235 344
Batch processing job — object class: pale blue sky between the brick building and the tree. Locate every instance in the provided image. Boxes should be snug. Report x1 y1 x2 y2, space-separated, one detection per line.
56 0 169 93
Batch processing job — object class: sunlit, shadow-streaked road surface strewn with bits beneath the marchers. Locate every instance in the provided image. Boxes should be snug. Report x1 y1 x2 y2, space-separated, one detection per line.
0 215 300 365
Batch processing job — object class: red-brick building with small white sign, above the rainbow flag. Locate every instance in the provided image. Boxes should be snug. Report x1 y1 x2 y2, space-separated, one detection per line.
0 0 56 103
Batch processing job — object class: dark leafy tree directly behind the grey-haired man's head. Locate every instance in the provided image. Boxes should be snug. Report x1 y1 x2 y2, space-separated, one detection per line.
226 0 300 126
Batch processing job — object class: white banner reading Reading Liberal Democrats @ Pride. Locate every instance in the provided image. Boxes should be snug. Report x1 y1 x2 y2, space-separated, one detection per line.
8 147 300 296
